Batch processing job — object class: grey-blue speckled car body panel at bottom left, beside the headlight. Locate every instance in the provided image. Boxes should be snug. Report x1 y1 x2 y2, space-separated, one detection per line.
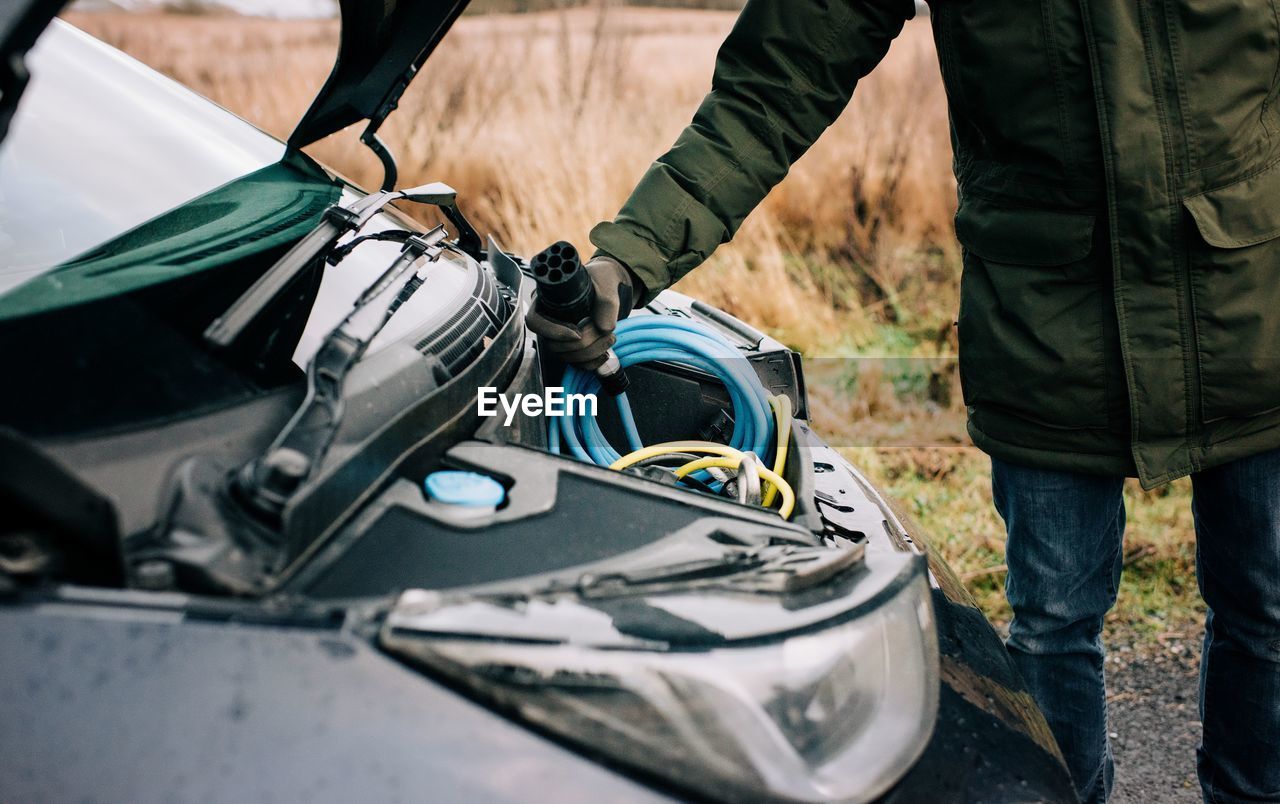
0 600 667 801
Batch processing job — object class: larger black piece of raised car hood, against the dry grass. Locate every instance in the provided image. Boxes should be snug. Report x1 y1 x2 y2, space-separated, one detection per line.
285 0 468 149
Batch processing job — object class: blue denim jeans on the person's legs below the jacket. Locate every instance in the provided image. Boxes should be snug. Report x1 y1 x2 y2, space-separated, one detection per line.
992 451 1280 803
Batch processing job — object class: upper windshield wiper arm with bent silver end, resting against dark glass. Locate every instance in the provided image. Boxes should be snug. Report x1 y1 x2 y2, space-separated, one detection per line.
205 182 481 348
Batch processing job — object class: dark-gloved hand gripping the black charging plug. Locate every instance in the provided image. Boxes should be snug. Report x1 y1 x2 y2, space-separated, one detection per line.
525 256 636 371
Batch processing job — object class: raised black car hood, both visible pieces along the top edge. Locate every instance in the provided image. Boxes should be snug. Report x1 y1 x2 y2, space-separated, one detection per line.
0 0 468 149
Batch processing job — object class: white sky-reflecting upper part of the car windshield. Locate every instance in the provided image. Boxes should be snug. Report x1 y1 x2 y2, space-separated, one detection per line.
0 20 284 294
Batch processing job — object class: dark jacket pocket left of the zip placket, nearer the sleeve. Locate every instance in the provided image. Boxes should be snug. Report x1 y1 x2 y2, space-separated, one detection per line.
956 198 1110 429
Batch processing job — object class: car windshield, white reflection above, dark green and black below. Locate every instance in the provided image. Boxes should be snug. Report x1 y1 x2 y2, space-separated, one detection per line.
0 22 342 437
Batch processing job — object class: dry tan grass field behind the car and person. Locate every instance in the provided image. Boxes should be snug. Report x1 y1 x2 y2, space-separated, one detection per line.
57 8 1198 636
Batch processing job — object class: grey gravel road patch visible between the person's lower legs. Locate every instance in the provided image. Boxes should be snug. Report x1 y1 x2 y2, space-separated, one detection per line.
1107 640 1201 804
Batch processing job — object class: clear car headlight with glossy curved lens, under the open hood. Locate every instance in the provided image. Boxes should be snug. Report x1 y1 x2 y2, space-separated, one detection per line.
383 556 938 801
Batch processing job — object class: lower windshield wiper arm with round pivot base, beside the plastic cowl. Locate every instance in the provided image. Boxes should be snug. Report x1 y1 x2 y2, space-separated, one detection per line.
236 227 447 517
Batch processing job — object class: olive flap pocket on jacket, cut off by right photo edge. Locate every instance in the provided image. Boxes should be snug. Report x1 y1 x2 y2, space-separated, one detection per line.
1183 156 1280 421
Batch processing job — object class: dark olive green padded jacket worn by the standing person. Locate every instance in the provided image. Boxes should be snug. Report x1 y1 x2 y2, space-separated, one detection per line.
591 0 1280 488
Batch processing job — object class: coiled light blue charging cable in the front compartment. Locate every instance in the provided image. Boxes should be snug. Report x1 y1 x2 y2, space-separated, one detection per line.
549 315 774 466
